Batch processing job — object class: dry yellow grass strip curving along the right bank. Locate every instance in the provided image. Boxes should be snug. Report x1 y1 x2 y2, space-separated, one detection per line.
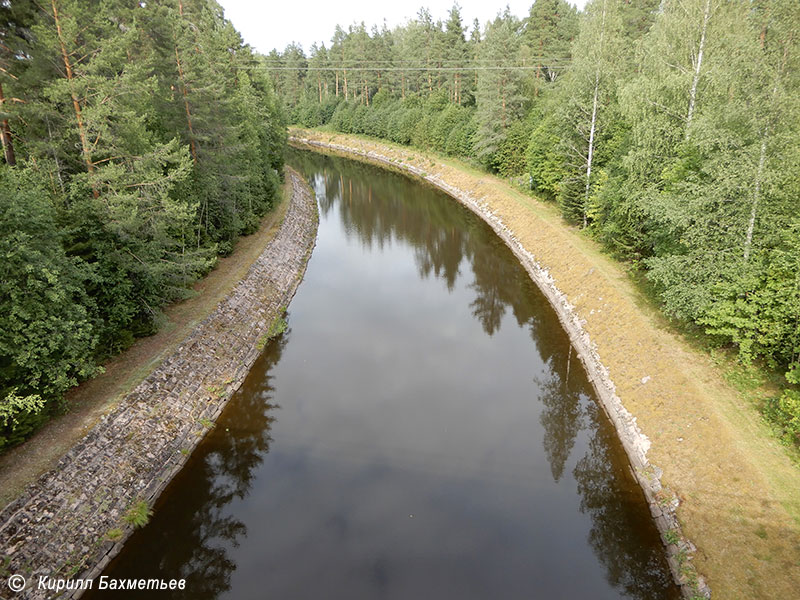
294 130 800 600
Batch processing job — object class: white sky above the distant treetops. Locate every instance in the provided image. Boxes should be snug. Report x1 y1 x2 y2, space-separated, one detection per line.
218 0 586 54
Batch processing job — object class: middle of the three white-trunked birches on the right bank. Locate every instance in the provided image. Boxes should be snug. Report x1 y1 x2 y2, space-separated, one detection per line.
615 0 750 256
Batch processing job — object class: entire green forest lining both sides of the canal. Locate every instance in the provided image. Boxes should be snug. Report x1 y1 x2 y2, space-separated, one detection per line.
0 0 800 449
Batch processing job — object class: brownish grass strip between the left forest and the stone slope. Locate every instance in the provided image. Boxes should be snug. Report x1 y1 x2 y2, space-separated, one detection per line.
0 178 291 507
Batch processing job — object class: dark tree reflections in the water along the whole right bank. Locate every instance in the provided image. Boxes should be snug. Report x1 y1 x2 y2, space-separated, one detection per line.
291 153 677 600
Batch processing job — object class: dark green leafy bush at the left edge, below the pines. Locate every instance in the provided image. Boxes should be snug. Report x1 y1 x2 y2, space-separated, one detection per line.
0 166 97 448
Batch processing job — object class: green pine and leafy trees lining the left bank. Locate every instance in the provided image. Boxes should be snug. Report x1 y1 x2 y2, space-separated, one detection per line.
0 0 286 448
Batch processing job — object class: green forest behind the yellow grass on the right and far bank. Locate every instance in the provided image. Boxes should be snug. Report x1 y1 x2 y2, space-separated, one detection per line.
264 0 800 443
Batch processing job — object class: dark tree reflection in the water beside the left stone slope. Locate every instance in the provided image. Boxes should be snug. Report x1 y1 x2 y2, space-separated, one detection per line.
90 332 289 599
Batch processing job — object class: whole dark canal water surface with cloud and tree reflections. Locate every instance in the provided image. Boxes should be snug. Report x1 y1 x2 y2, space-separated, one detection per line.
92 152 678 600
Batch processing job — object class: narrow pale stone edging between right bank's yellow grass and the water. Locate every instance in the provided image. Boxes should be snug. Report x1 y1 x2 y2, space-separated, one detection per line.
289 132 711 598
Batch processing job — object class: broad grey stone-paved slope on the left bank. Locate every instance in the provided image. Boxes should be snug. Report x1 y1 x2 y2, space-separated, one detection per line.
0 169 318 600
